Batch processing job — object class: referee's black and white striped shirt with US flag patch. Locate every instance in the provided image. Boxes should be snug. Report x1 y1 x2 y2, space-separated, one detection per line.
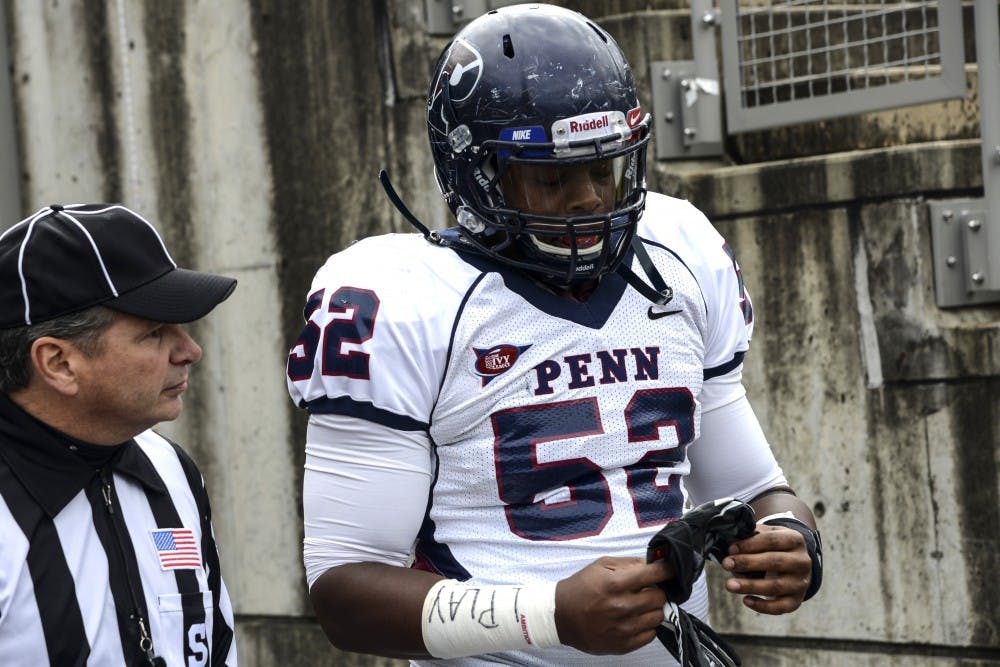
0 394 236 667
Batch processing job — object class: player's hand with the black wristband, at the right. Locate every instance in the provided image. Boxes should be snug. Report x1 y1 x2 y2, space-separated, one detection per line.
722 525 812 614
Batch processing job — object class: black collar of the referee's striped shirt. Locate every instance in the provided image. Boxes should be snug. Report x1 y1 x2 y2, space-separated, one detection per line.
0 393 167 517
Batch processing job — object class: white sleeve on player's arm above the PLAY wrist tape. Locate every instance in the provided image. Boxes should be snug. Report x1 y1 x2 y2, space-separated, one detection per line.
302 414 432 588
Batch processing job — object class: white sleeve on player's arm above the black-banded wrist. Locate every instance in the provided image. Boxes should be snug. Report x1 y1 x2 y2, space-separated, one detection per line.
684 367 787 506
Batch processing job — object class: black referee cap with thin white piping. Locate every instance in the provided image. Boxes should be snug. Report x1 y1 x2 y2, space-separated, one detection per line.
0 204 236 329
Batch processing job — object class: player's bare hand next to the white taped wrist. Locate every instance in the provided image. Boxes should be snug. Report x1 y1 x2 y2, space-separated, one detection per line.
556 557 673 655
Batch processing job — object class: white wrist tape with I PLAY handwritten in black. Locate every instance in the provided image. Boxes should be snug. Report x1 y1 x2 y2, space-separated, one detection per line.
420 579 560 658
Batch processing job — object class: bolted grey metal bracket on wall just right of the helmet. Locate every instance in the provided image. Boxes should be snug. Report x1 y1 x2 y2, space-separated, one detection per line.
649 60 722 160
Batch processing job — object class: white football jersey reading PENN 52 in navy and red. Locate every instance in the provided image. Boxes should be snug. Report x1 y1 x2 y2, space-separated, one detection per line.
288 193 764 665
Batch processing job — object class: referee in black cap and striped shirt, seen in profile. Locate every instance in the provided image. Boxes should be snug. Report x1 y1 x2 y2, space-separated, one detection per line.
0 204 236 667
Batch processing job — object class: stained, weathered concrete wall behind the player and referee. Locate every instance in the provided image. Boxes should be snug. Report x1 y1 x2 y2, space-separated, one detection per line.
0 0 1000 667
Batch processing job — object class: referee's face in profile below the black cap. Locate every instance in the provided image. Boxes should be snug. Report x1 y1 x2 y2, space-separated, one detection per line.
73 313 201 440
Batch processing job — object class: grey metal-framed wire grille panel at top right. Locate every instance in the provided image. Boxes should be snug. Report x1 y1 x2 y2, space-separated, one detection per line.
721 0 965 132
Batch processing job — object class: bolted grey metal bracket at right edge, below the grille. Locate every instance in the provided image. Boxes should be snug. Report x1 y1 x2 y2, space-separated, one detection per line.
928 199 1000 308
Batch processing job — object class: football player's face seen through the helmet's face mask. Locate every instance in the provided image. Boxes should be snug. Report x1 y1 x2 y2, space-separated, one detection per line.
502 159 618 250
